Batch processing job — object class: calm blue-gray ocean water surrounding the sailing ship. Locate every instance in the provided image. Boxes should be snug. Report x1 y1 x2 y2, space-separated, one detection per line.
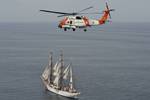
0 23 150 100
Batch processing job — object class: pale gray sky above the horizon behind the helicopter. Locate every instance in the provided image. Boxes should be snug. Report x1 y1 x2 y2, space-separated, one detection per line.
0 0 150 22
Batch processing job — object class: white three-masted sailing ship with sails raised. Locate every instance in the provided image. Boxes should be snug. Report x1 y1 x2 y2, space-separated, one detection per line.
41 52 80 98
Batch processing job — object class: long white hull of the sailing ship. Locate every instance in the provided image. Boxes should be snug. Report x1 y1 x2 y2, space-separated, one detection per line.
41 77 80 98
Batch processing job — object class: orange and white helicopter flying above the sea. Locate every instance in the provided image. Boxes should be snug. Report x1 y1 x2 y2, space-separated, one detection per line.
40 2 115 31
